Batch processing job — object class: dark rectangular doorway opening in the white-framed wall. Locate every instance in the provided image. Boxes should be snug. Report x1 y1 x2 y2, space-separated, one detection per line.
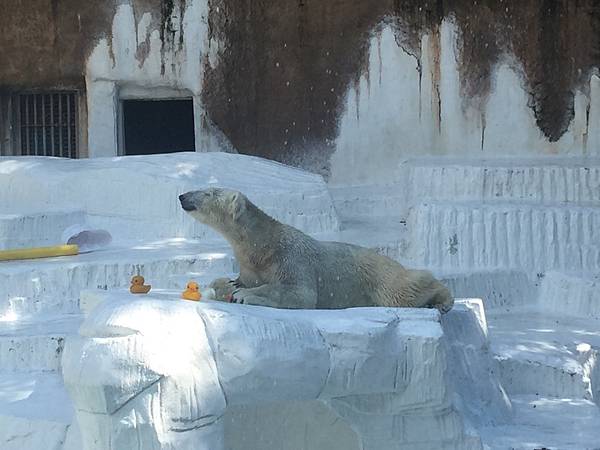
122 98 196 155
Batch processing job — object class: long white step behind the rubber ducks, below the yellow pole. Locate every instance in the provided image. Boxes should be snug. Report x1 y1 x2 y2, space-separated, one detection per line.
0 240 237 321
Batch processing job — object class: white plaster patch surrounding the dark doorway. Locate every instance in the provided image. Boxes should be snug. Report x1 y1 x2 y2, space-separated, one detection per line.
86 0 231 157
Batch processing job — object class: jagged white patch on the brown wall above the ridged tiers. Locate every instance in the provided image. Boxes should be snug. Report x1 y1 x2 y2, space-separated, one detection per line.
331 20 600 185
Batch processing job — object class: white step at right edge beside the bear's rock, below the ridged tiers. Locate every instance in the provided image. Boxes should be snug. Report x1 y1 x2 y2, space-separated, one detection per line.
487 307 600 404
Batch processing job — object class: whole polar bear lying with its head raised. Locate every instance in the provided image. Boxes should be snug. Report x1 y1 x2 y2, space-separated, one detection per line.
179 188 454 313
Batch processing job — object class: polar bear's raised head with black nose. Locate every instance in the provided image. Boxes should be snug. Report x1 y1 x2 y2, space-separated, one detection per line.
179 188 248 231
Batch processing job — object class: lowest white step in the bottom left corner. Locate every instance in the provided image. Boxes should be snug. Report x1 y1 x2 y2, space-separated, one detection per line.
0 372 77 450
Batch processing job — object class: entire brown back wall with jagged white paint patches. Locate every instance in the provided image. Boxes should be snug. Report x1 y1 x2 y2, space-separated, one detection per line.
0 0 600 182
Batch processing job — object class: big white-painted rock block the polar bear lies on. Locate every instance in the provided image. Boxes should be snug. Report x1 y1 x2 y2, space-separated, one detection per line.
63 293 481 450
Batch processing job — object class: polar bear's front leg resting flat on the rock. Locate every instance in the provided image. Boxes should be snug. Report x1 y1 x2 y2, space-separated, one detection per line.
232 284 317 309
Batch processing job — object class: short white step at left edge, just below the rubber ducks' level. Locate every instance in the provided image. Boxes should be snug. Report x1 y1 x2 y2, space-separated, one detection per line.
0 314 82 372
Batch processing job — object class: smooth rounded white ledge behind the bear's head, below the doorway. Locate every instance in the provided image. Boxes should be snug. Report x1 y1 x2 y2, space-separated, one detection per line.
0 153 339 242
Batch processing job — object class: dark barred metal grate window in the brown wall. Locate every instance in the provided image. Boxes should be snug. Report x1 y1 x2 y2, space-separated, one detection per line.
15 91 78 158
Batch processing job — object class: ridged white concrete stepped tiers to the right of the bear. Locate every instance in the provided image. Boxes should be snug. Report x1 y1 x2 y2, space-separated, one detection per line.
332 158 600 450
